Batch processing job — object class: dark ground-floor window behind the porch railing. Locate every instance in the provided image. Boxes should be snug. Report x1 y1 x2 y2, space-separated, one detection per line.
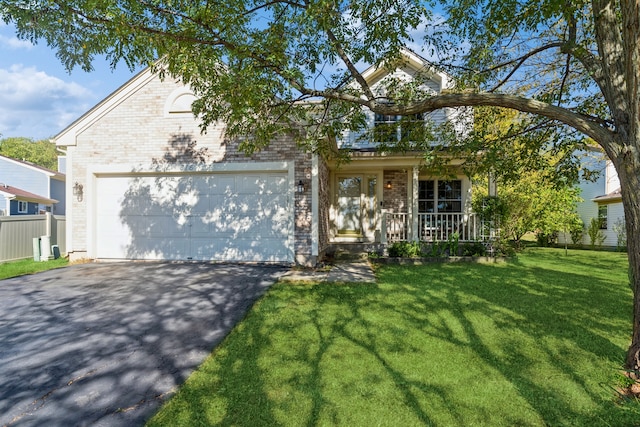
418 179 462 213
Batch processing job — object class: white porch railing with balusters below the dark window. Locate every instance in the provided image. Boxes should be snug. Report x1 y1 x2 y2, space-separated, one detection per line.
382 212 490 243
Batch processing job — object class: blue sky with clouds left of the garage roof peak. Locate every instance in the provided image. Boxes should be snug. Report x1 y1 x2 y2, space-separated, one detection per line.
0 22 135 140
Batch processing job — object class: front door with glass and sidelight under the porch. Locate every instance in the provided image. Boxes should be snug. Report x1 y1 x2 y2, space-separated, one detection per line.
336 175 378 239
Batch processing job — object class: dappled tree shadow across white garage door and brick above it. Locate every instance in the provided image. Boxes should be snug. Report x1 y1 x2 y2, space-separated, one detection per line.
115 134 292 262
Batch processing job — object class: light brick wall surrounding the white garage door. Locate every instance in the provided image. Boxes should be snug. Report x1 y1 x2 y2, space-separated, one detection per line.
67 71 311 259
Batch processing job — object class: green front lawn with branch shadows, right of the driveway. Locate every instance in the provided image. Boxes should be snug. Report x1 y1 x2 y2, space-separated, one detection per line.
149 248 640 426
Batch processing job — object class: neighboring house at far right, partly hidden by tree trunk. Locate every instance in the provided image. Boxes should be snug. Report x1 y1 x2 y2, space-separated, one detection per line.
559 149 625 247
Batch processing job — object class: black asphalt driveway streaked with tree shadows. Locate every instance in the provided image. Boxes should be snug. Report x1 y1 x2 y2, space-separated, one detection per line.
0 262 285 426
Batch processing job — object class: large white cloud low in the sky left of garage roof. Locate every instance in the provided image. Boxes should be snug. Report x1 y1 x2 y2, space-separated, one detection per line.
0 64 96 139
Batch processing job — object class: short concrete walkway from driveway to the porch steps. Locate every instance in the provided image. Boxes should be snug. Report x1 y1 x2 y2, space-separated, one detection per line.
280 259 376 283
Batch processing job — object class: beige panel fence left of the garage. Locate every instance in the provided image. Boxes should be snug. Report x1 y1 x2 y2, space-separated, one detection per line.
0 214 66 262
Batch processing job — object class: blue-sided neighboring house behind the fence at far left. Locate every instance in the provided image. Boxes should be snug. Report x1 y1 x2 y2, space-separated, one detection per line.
0 155 66 215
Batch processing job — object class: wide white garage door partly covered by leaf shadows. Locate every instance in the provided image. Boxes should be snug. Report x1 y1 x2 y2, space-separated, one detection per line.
95 173 293 262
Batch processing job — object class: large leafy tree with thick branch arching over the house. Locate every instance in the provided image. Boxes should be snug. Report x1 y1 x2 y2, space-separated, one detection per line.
0 0 640 371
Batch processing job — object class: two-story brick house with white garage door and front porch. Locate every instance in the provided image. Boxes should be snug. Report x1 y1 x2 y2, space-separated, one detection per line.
54 52 479 264
